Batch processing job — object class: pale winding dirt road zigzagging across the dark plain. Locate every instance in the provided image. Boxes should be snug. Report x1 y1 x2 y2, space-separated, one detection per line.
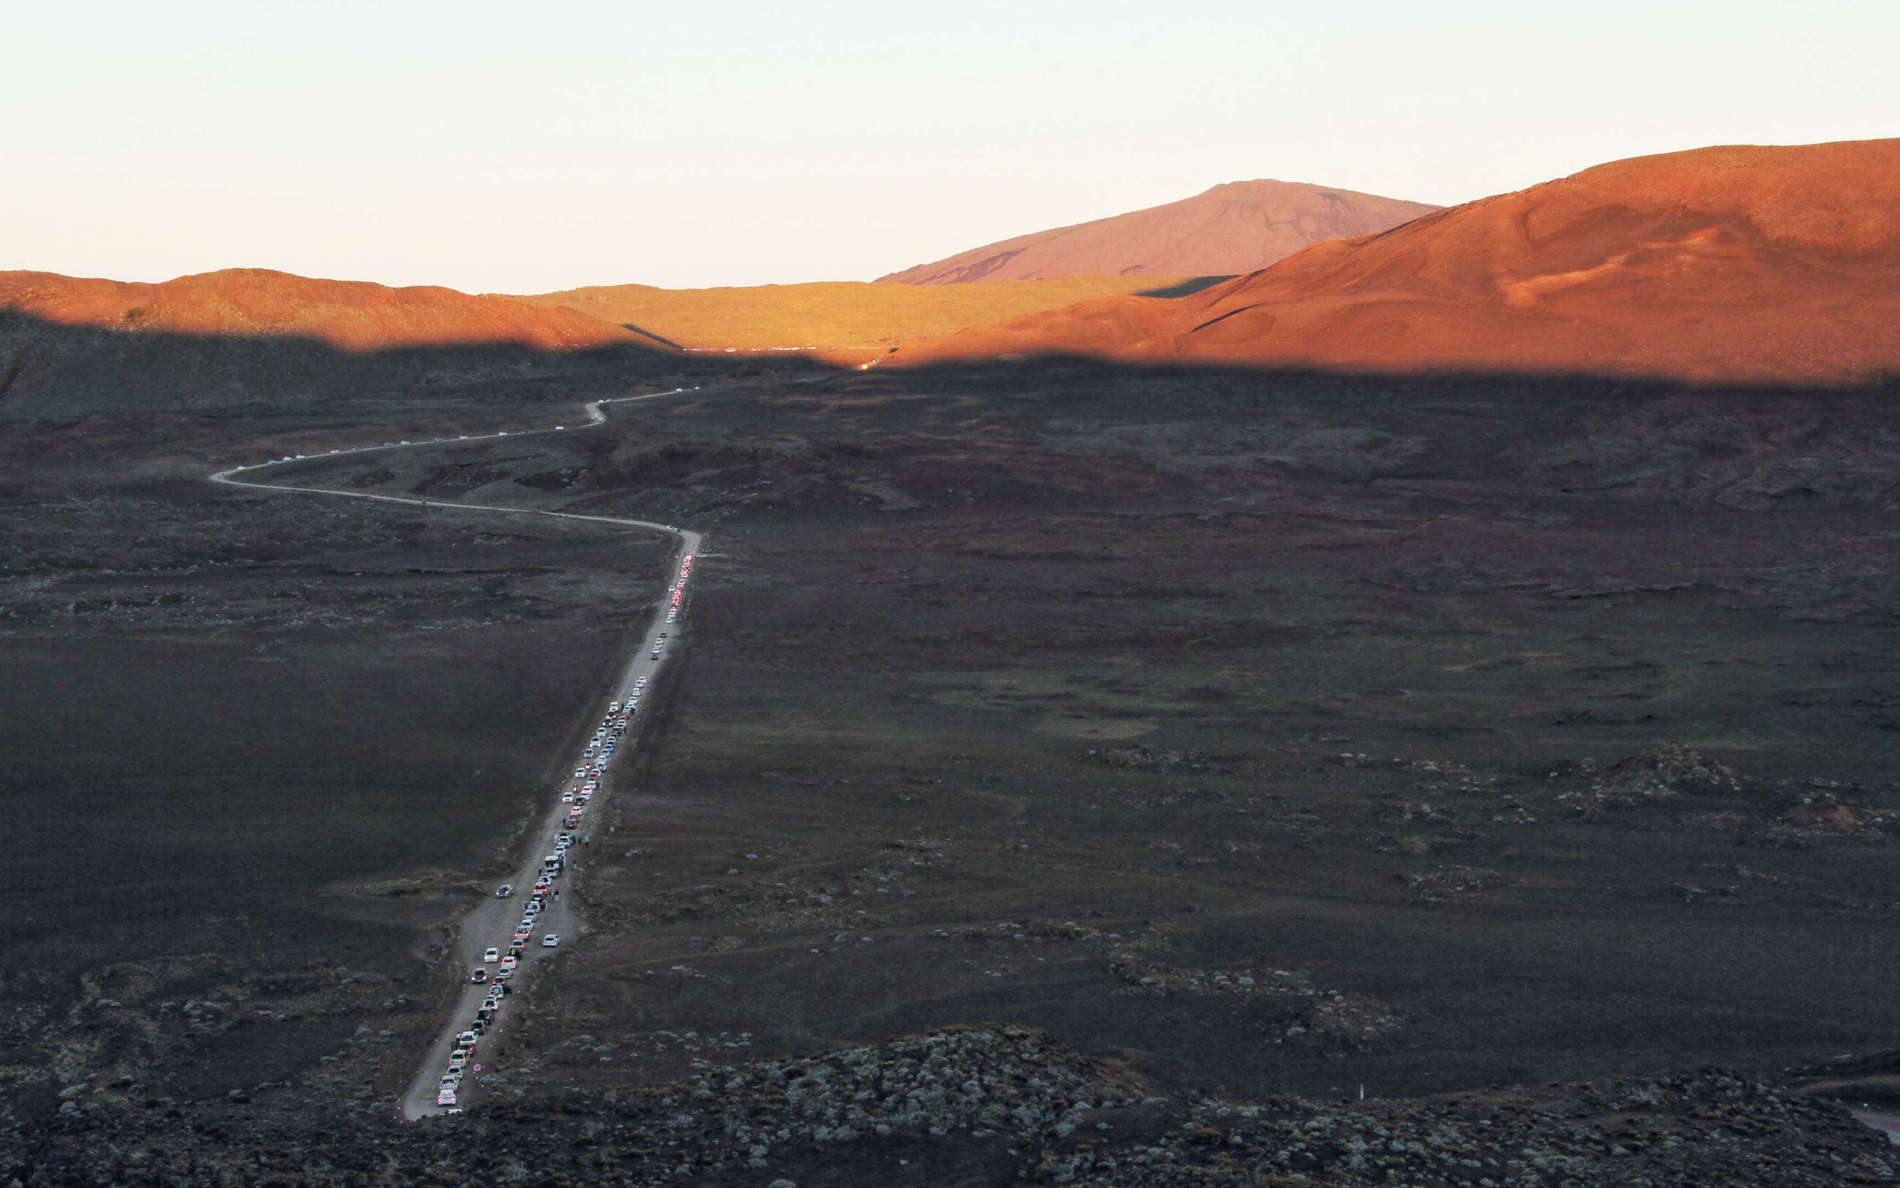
207 388 703 1121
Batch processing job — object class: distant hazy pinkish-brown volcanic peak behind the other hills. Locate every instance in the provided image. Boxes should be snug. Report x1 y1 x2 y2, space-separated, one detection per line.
878 181 1438 285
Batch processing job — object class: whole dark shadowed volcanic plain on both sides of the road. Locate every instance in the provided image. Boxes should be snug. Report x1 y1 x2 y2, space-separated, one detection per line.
0 345 1900 1186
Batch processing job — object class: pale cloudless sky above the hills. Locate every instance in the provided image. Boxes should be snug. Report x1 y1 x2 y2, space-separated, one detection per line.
0 0 1900 293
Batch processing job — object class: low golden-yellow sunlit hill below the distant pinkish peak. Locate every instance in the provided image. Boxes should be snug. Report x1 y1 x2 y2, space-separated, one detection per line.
517 270 1193 361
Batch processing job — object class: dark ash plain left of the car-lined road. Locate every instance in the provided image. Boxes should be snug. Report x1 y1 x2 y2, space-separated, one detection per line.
0 366 691 1116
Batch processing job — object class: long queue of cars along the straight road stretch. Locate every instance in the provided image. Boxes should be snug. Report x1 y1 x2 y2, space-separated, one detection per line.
435 553 695 1108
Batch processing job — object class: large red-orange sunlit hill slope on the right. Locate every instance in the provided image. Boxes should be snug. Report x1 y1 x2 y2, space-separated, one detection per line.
891 139 1900 382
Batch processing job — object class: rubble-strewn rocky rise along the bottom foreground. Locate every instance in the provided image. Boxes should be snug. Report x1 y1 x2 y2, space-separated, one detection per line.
0 1026 1900 1188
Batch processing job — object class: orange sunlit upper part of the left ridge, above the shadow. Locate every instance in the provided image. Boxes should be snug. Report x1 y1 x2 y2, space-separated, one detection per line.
0 268 638 352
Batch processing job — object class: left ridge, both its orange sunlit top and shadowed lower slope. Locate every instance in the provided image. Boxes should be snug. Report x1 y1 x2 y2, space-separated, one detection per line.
0 268 688 418
